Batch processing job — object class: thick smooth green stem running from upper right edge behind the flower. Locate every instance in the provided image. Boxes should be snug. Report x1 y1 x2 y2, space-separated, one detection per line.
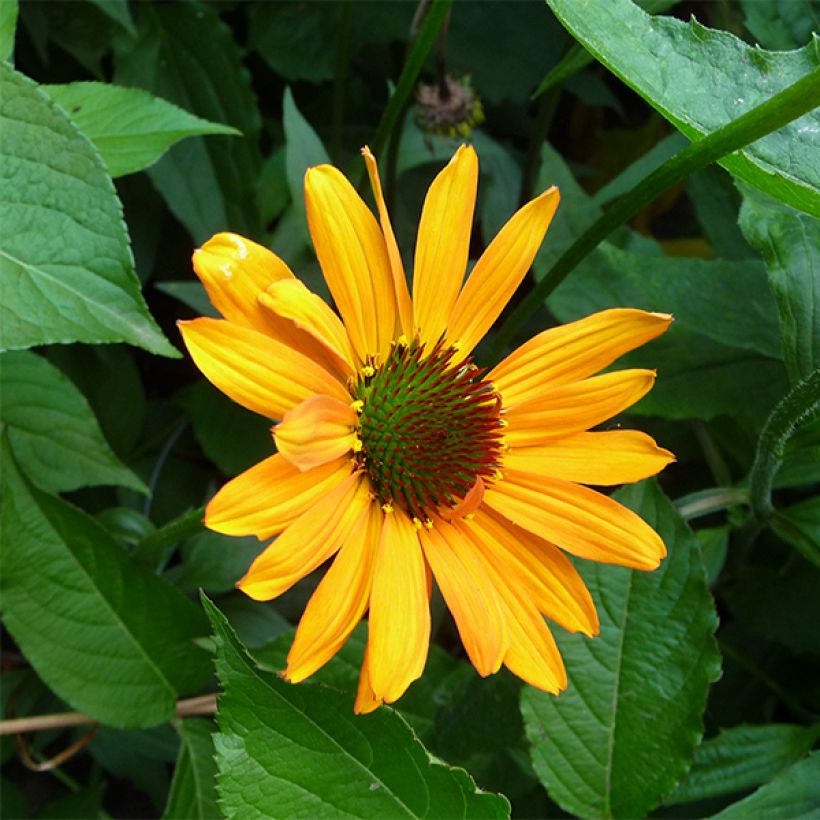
494 68 820 354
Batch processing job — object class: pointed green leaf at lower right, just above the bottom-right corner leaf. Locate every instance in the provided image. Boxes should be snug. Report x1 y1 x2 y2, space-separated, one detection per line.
666 724 820 805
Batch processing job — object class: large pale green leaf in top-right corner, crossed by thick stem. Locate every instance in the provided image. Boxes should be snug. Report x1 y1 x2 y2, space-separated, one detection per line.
547 0 820 216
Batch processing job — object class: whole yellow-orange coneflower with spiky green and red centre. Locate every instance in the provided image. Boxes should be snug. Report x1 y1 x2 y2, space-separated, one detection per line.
180 146 673 712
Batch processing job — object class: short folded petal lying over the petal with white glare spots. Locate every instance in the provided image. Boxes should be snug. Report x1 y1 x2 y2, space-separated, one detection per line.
259 279 356 376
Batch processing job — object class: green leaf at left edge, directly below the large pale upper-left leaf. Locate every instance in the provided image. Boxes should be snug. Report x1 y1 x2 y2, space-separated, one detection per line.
0 351 148 493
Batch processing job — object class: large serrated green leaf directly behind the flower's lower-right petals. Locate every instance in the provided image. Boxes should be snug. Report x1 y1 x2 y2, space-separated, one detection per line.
521 482 720 817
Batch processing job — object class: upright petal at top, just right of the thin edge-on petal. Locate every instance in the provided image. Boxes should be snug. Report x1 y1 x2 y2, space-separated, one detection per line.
413 145 478 345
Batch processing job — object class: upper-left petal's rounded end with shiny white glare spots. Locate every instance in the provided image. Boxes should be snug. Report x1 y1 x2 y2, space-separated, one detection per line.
193 233 294 333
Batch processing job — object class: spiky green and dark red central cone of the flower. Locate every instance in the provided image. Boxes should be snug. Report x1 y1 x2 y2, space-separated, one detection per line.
353 334 503 521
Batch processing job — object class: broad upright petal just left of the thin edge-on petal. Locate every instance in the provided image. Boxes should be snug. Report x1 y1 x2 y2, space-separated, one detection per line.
305 165 396 361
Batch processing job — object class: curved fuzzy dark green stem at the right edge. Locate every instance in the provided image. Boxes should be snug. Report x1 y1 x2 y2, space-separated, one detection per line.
749 368 820 522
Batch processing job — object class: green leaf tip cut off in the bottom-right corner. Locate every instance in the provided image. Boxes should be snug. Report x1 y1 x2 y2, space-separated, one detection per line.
715 751 820 820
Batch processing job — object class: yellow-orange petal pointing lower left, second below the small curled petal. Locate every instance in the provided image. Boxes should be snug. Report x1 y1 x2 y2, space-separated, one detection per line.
237 474 370 601
